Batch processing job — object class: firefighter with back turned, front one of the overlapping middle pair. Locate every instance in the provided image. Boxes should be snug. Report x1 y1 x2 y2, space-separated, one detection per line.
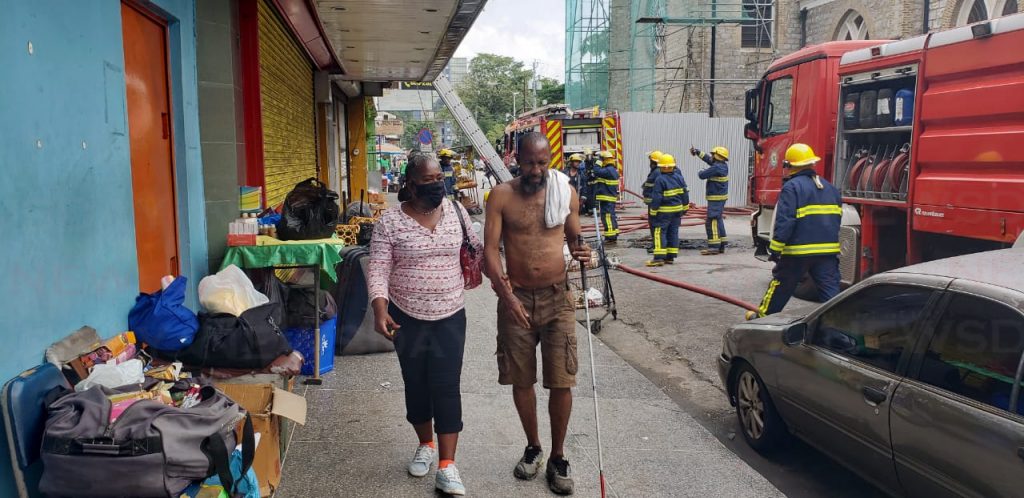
647 154 690 266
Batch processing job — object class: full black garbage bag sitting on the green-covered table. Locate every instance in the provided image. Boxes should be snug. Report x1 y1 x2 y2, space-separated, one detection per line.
278 178 339 241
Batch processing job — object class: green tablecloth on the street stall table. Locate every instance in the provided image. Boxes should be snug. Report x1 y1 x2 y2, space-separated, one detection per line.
220 237 344 282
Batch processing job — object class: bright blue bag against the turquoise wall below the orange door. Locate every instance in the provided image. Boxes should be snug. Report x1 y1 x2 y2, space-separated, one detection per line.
128 277 199 351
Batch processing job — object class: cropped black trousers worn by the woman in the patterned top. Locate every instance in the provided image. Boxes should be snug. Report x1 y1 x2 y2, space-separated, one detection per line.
388 304 466 434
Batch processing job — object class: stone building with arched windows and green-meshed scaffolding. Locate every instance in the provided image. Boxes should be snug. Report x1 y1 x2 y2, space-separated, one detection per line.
585 0 1024 117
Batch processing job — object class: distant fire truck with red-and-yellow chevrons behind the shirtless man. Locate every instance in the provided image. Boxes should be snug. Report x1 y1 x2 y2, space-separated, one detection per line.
498 103 623 172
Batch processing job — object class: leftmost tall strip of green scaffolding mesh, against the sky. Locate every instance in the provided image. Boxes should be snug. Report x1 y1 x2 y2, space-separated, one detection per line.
565 0 610 109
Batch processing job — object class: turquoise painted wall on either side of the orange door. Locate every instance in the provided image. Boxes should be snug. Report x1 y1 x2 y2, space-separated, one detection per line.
0 0 207 497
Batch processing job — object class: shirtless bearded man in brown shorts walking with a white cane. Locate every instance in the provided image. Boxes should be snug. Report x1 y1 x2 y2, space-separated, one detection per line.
483 133 590 495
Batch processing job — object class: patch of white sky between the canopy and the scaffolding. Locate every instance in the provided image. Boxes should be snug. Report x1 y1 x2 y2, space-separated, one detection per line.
455 0 565 81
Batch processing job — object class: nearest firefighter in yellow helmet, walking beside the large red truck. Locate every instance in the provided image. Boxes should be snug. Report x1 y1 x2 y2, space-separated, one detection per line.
746 143 843 320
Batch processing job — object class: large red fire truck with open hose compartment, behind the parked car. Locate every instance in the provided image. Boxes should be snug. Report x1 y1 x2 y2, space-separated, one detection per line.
745 14 1024 285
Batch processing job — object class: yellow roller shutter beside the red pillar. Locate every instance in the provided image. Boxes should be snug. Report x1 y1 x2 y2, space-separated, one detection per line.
259 0 316 206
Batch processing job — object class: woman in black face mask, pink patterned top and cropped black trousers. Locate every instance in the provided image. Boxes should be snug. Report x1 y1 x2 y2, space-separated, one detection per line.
368 154 483 495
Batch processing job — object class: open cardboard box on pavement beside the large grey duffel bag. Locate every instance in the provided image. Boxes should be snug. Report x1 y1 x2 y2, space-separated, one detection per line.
214 382 306 497
